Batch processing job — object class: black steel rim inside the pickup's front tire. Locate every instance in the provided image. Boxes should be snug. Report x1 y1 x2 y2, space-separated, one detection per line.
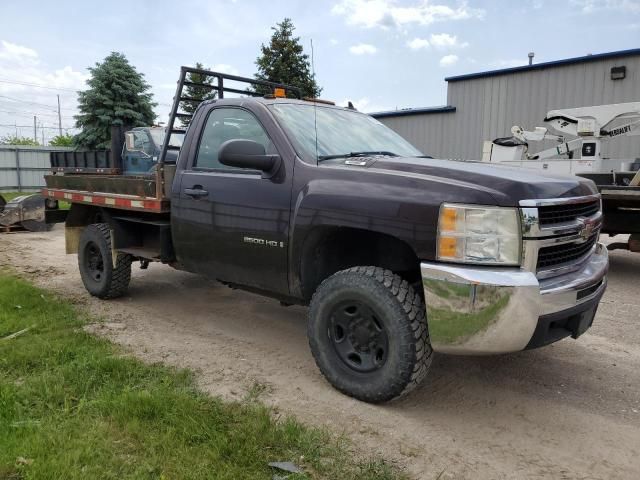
328 300 389 373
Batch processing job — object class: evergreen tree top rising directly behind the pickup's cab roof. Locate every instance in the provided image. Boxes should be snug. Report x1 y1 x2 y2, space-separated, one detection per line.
254 18 322 97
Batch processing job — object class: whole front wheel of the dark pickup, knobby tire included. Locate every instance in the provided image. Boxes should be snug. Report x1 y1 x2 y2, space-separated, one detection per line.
308 267 433 403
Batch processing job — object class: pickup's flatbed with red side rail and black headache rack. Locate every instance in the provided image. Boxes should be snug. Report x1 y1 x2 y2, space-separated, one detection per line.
42 67 302 213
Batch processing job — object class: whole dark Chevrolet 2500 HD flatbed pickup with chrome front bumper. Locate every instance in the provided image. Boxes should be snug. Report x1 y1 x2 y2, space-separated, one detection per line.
43 67 608 403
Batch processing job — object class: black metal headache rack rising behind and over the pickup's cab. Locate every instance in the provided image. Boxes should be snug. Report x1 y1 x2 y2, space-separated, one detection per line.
156 66 302 199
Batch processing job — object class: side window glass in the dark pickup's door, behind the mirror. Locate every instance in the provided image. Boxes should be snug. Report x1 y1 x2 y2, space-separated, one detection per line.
193 108 274 170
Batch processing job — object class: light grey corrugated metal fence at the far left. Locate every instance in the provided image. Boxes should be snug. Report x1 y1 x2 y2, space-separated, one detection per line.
0 145 73 191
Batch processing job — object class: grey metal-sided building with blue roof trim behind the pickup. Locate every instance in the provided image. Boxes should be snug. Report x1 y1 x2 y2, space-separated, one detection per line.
372 48 640 160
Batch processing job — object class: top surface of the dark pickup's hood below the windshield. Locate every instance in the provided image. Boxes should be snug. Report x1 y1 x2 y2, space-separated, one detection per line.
360 157 598 206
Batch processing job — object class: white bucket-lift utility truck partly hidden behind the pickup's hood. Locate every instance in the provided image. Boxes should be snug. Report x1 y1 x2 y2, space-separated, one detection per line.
483 102 640 252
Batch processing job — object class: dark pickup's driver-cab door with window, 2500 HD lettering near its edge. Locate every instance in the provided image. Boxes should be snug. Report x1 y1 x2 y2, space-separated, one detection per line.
172 106 293 294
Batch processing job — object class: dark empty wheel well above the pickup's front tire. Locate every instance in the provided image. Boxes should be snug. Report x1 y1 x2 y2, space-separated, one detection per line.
300 227 421 301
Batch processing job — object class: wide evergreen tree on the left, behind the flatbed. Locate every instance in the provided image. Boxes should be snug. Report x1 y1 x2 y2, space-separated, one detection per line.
74 52 156 149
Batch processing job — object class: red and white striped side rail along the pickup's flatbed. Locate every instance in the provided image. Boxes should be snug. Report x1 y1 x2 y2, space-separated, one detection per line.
42 188 170 213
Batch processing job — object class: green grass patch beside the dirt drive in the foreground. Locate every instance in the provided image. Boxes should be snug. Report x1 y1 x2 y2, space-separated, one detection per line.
0 272 404 480
